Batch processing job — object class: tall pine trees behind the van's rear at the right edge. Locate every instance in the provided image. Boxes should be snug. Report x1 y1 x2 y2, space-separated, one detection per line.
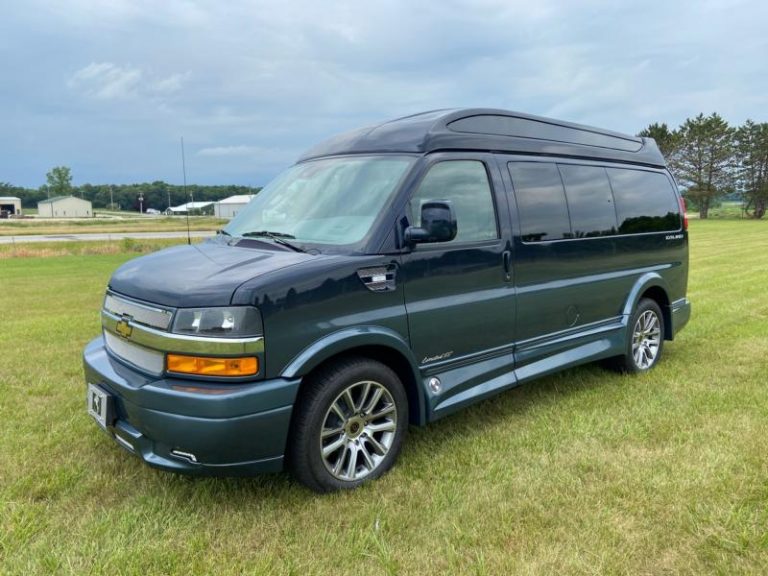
638 113 768 218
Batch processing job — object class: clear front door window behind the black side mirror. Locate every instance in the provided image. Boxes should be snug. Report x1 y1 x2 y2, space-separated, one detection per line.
410 160 499 242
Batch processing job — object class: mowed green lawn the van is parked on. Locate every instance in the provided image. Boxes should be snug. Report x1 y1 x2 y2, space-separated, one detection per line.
0 221 768 575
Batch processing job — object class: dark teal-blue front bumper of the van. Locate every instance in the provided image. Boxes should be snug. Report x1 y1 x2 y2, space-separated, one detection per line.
83 337 300 476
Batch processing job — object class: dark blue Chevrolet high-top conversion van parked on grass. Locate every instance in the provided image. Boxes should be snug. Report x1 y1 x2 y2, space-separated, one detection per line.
84 109 690 491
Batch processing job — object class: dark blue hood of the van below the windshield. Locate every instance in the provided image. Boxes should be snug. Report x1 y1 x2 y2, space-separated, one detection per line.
109 242 313 308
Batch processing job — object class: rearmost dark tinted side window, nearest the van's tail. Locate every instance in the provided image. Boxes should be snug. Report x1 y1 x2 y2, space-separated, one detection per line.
607 168 680 234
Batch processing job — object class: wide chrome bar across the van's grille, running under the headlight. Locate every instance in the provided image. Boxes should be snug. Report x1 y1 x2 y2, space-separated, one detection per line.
101 310 264 356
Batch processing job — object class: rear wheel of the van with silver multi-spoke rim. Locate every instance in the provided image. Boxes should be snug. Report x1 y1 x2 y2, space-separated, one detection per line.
609 298 664 374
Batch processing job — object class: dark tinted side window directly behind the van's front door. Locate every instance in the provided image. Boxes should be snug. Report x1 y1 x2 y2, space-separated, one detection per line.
508 162 571 242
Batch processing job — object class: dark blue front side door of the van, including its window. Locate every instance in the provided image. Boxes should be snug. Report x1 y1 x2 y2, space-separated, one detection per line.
401 155 515 410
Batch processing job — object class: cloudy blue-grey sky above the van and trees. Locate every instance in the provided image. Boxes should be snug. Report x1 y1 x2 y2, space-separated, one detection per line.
0 0 768 188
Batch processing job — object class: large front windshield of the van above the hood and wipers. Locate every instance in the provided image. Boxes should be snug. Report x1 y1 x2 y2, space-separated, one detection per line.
225 156 413 245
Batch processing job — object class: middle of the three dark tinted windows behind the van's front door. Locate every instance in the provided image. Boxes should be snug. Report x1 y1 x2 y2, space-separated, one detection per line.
558 164 617 238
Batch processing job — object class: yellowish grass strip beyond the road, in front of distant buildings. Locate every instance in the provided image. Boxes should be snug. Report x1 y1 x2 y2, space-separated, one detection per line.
0 216 229 236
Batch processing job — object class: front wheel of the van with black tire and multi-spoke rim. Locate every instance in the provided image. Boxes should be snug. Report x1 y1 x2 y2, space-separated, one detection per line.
287 358 408 492
